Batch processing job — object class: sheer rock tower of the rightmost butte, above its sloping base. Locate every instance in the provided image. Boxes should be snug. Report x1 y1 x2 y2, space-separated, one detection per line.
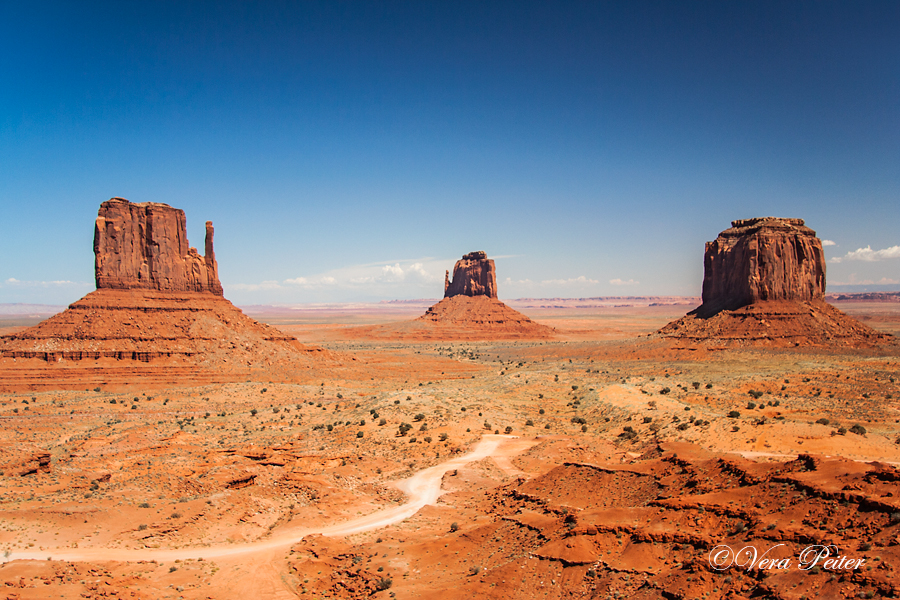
703 217 825 310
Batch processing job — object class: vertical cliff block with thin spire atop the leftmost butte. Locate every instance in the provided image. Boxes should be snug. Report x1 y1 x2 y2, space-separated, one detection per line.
94 198 223 296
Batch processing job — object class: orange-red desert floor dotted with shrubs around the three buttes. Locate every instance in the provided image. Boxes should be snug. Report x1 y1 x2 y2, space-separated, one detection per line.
0 301 900 600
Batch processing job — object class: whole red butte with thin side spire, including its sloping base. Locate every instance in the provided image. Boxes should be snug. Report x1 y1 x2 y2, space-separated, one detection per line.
0 198 332 390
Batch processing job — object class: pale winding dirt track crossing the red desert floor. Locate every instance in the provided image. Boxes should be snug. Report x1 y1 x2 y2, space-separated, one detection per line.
0 435 538 562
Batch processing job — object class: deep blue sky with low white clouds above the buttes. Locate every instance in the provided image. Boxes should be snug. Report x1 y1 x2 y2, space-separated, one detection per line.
0 0 900 304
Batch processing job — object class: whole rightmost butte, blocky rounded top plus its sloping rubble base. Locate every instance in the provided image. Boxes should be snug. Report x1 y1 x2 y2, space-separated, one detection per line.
659 217 892 347
